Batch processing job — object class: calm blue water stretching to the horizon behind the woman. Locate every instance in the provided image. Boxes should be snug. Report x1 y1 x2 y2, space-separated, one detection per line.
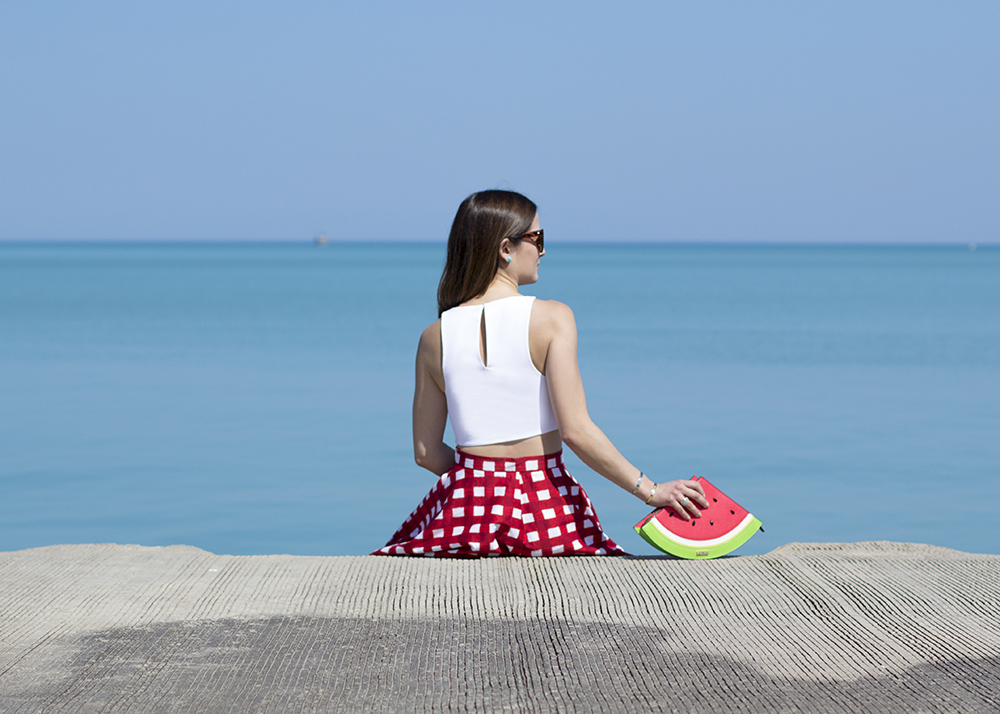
0 244 1000 554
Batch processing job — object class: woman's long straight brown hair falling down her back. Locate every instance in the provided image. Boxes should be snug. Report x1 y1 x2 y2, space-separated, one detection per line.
438 190 538 317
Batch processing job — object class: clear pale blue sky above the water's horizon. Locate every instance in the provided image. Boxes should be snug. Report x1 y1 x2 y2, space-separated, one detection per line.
0 0 1000 242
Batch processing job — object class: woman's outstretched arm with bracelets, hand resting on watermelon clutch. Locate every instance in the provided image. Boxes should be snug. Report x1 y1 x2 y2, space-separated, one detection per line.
532 301 708 518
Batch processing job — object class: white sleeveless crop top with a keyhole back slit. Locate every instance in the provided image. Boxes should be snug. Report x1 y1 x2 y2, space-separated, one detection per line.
441 295 558 446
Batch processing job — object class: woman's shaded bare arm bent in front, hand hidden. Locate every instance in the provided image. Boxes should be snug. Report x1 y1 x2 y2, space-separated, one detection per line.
413 320 455 476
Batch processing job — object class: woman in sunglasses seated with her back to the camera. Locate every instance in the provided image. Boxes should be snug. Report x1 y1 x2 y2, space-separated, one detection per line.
375 191 708 557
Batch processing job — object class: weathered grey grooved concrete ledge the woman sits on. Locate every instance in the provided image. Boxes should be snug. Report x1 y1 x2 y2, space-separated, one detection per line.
0 543 1000 712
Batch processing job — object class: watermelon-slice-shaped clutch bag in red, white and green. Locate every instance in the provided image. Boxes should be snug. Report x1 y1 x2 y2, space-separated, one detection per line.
635 476 761 560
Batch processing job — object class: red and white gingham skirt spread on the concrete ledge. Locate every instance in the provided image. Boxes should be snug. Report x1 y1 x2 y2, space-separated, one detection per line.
372 451 625 558
